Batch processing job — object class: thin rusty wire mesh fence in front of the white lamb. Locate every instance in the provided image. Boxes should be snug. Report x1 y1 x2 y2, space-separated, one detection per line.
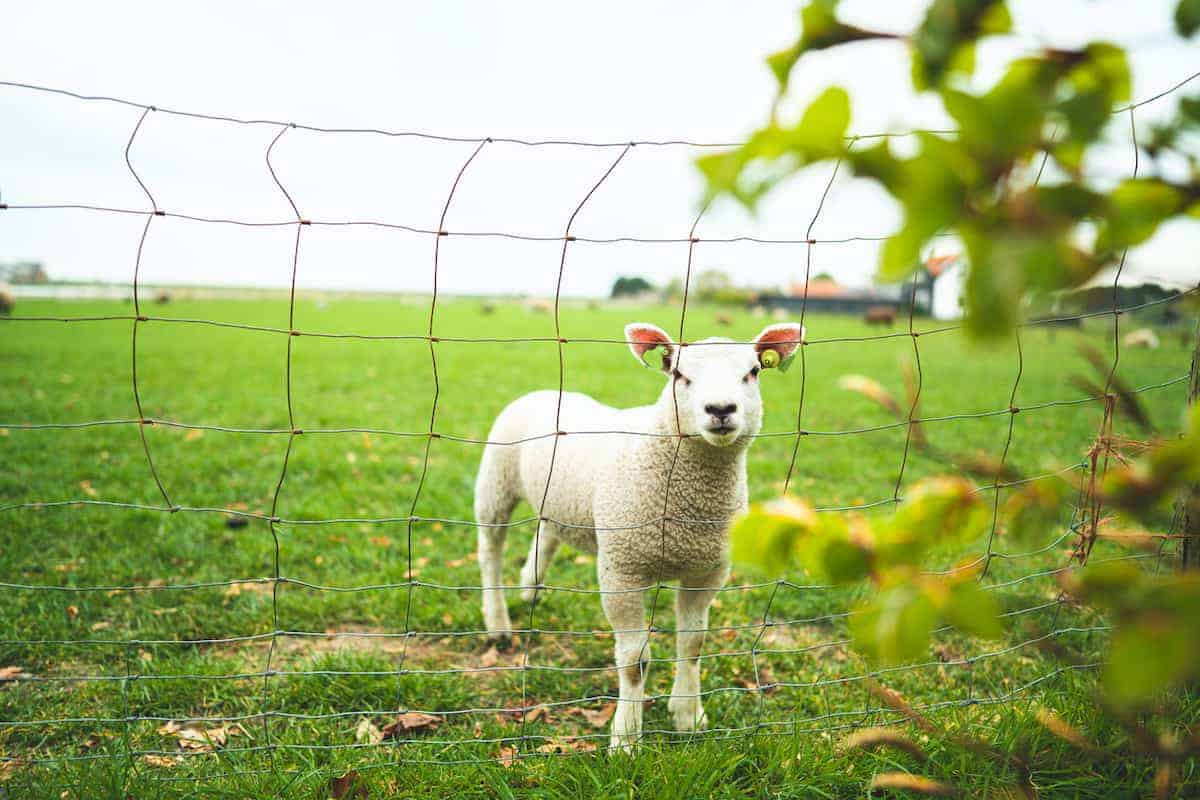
0 72 1200 783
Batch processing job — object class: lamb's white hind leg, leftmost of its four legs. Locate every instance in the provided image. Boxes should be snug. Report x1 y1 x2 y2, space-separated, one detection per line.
475 447 517 639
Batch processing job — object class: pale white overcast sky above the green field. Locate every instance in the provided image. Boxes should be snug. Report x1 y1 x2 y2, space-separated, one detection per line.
0 0 1200 295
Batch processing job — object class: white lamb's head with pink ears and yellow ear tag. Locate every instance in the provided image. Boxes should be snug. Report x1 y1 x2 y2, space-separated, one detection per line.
625 323 804 447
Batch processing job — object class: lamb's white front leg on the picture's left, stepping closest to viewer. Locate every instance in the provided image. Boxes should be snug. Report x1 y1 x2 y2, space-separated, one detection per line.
600 571 650 752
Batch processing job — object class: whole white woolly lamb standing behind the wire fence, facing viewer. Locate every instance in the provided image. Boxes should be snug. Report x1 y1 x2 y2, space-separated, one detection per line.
475 323 804 748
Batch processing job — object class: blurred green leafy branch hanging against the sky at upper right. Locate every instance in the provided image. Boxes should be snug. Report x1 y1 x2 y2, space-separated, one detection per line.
697 0 1200 337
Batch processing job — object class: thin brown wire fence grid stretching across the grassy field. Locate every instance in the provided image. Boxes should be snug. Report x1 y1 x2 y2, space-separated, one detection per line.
0 73 1200 781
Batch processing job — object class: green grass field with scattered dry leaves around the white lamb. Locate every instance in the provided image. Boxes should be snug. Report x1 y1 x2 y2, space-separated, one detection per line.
0 299 1200 799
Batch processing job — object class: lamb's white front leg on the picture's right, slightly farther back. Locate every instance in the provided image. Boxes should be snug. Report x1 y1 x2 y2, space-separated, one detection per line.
667 566 730 730
